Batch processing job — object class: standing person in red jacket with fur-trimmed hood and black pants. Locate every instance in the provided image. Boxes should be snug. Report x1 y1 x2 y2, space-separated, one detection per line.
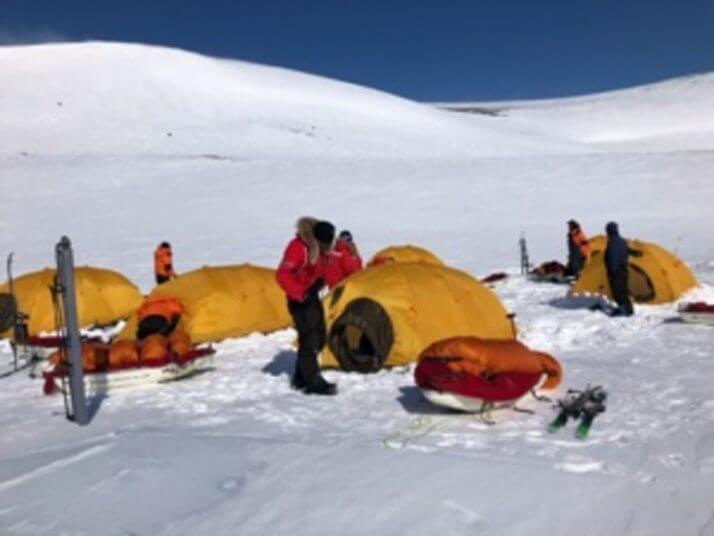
276 218 337 395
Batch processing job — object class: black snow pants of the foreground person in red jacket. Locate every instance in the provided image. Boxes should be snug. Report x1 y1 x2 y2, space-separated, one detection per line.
288 290 327 384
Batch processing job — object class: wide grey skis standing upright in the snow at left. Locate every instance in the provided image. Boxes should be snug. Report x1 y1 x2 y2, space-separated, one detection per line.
55 236 89 425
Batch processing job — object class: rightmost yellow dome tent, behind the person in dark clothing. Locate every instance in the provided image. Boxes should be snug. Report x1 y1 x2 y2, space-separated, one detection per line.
570 236 698 304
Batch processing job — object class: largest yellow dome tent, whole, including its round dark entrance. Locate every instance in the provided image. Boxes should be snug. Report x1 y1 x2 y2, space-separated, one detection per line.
322 263 515 372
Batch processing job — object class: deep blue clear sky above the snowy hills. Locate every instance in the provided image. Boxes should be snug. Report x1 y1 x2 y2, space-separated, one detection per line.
0 0 714 101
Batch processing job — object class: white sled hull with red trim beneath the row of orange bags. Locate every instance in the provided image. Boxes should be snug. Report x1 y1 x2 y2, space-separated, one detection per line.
42 347 215 395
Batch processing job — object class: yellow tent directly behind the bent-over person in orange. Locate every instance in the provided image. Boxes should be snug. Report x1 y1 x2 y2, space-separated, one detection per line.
118 264 292 343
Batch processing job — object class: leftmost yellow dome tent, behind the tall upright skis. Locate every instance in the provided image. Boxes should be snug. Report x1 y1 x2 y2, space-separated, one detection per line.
0 266 142 337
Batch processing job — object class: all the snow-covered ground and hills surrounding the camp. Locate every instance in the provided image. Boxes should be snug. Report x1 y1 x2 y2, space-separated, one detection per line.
0 43 714 535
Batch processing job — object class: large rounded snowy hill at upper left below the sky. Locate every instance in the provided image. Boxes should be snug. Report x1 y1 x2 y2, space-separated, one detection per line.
0 42 564 158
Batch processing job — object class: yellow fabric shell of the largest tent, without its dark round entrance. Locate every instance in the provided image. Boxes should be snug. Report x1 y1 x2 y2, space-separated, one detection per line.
322 263 515 367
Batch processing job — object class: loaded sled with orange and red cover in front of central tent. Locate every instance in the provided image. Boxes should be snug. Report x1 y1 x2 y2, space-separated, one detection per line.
414 337 562 412
